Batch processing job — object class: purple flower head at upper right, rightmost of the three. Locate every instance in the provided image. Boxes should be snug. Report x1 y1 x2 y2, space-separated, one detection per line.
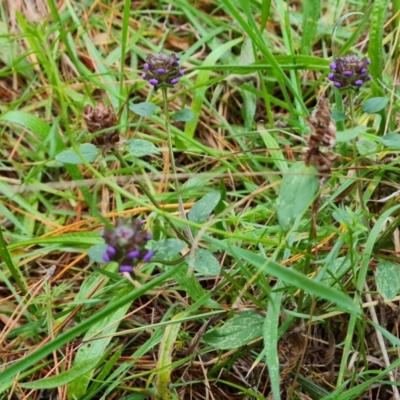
328 54 371 89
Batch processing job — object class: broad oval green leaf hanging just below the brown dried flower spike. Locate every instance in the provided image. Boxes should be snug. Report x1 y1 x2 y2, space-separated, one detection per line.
277 162 319 232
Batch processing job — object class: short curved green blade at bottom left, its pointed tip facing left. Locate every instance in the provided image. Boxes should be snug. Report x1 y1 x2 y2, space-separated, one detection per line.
21 358 99 389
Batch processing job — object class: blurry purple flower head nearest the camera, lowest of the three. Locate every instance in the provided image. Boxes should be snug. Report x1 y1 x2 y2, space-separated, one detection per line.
103 219 154 273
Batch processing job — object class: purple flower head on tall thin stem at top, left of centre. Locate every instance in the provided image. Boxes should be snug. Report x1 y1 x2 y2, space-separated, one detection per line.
142 53 183 89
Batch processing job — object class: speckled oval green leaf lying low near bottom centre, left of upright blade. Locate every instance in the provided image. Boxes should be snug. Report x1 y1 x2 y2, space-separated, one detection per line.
202 311 265 350
